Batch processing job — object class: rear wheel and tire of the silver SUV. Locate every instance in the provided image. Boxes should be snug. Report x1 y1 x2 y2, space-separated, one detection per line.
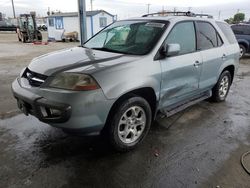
211 70 232 102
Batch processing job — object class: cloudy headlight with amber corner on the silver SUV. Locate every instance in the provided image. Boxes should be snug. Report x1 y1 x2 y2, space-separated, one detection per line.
49 73 100 91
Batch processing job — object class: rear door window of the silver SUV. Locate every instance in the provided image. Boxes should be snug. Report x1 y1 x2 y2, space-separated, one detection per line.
197 22 218 50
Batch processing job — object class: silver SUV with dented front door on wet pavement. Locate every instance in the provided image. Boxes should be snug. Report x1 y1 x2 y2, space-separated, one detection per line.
12 13 240 151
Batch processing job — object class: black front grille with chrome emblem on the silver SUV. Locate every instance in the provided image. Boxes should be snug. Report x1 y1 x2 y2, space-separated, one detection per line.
23 68 48 87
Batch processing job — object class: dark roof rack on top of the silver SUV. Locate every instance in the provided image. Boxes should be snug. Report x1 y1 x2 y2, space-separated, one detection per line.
142 11 213 18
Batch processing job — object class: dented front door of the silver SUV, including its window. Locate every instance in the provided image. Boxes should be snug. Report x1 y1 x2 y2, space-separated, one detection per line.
160 21 202 107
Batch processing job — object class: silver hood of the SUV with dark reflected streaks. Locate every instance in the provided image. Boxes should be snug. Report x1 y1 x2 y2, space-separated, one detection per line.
28 47 139 76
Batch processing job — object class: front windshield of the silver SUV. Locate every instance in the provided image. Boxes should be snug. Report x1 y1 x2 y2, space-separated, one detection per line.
84 20 166 55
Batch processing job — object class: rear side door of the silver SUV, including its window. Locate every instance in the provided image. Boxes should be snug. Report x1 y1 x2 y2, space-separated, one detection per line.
196 21 227 91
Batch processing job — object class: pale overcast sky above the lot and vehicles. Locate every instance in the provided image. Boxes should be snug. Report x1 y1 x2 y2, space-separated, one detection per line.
0 0 250 20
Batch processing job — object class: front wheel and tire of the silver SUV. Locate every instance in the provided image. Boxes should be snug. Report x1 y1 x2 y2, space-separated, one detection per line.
107 96 152 152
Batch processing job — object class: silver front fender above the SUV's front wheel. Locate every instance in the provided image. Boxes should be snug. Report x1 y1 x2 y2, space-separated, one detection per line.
93 57 161 100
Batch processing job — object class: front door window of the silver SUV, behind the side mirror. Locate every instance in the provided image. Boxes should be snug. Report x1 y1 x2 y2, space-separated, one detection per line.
166 22 196 55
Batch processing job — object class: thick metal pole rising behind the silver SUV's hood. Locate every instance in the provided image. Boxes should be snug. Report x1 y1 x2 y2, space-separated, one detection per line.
78 0 87 45
